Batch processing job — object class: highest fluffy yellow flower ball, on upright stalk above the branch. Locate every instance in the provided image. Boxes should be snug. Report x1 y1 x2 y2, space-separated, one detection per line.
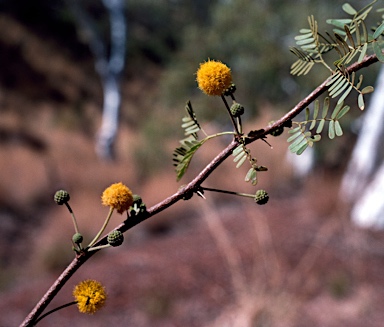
196 60 232 95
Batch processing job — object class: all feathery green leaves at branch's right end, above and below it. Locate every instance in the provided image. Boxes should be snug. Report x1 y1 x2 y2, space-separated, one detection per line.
288 0 384 154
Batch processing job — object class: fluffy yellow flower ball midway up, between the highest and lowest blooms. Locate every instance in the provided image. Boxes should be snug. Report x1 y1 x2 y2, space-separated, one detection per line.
101 183 133 214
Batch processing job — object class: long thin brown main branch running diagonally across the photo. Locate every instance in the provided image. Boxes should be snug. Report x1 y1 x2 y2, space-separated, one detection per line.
20 55 378 327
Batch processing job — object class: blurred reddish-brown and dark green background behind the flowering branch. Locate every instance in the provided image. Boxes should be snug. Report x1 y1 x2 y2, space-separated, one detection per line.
0 0 384 327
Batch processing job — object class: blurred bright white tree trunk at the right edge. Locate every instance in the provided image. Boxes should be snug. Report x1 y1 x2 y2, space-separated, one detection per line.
341 66 384 228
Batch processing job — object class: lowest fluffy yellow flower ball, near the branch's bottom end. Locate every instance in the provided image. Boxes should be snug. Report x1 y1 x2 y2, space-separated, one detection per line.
73 279 107 314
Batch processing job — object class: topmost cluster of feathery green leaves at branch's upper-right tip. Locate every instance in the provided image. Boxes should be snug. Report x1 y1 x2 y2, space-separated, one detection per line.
291 0 384 110
